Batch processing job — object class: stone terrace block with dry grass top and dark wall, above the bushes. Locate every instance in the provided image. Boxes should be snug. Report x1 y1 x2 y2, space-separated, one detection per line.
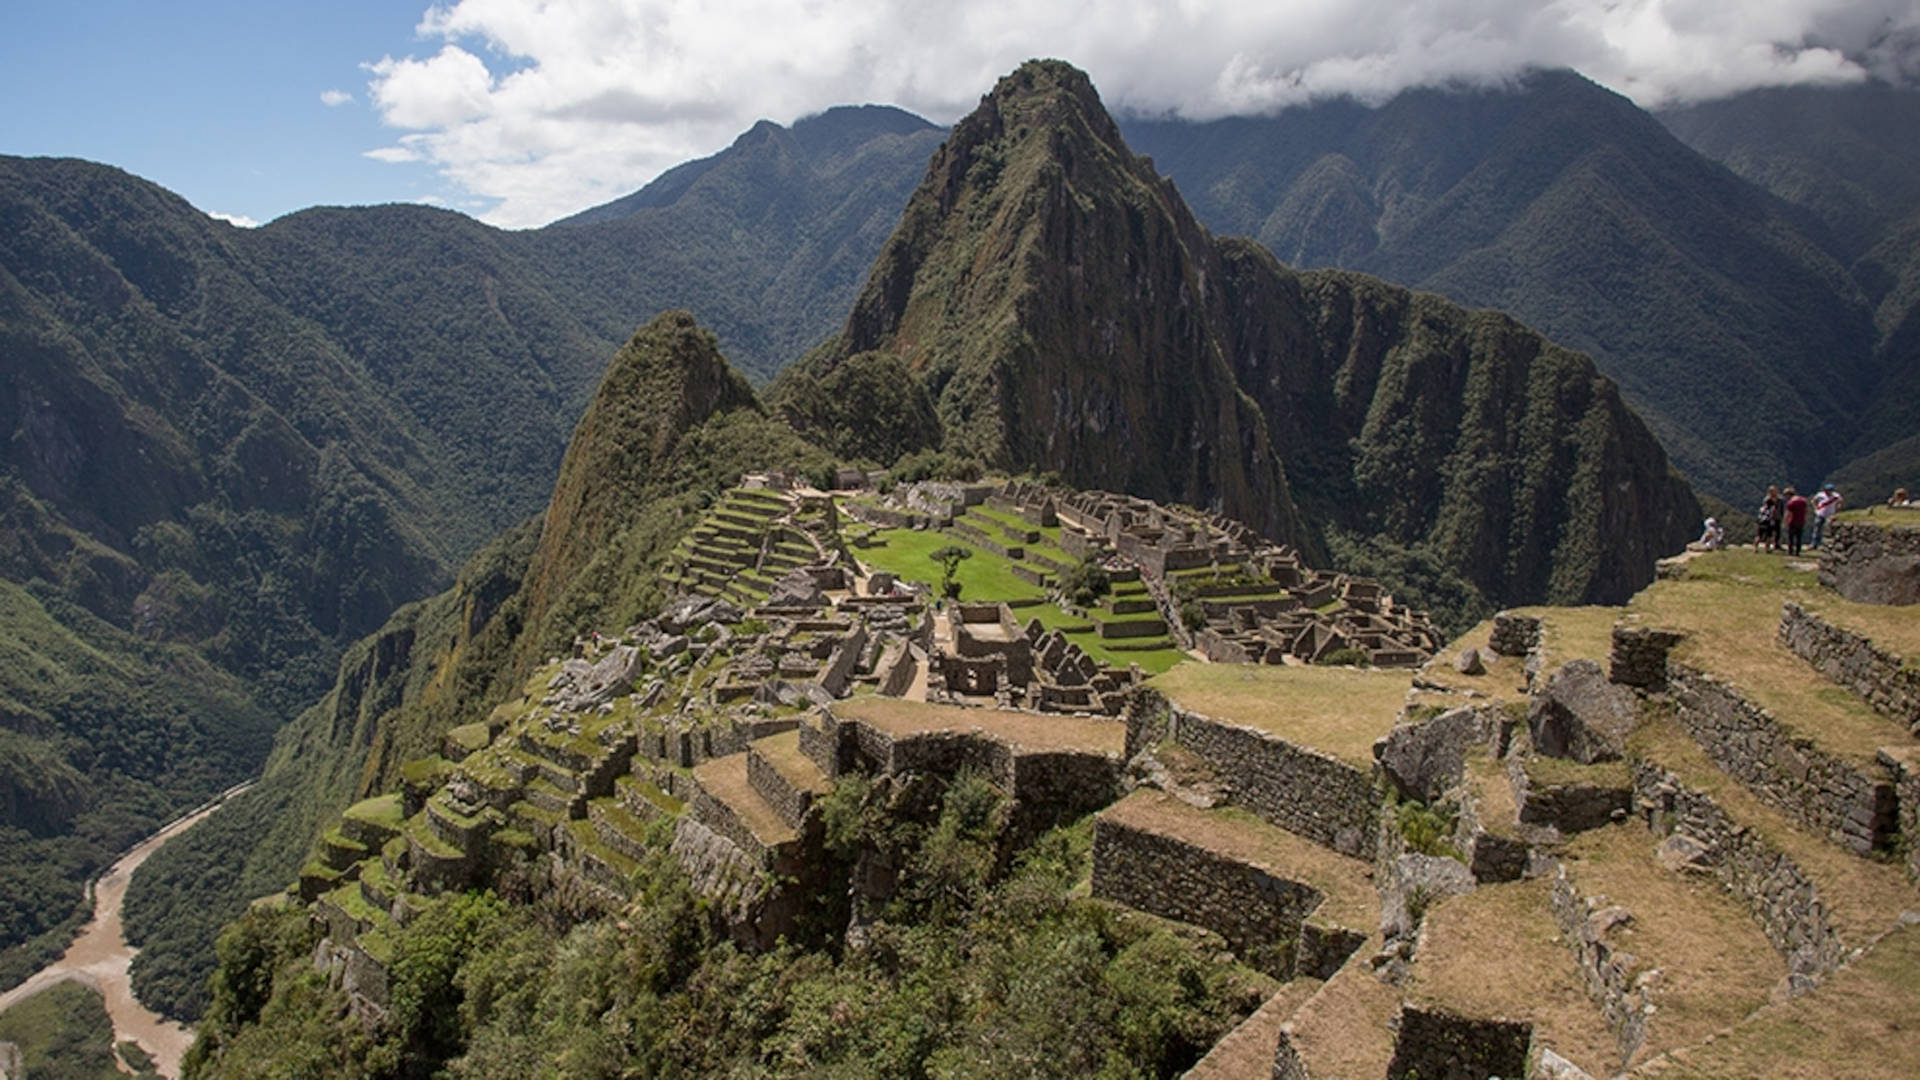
1092 788 1379 980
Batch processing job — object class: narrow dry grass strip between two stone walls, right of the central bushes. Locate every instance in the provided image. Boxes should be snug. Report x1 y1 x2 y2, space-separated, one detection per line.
1100 790 1380 932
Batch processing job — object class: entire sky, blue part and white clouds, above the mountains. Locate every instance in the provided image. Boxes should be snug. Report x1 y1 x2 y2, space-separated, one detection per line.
0 0 1920 229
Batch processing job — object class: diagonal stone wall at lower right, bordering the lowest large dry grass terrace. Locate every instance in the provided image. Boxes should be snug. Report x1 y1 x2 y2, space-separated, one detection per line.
1634 761 1847 976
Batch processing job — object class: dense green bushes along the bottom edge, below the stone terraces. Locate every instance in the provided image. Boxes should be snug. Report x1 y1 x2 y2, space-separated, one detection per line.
186 776 1271 1080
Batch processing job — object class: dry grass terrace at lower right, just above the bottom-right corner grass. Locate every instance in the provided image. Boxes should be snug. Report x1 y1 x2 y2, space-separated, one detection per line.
1565 822 1788 1057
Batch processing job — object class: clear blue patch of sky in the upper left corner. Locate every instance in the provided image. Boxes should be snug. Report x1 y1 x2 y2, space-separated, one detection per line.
0 0 449 221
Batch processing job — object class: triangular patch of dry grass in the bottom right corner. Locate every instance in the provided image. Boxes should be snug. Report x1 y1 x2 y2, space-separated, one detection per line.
1647 914 1920 1080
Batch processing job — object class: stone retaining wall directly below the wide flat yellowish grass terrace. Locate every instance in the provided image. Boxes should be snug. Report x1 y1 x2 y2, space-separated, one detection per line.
1159 707 1379 859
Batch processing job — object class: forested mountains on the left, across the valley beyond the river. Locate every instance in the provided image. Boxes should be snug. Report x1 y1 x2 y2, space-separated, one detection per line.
0 110 937 982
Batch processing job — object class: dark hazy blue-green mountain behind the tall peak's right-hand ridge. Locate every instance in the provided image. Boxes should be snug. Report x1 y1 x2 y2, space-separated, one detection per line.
1123 71 1881 505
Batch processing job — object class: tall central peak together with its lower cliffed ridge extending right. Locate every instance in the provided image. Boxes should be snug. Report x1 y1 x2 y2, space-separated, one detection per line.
770 63 1699 619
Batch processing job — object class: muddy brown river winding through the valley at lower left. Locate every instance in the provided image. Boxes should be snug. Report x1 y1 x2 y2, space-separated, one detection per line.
0 780 252 1078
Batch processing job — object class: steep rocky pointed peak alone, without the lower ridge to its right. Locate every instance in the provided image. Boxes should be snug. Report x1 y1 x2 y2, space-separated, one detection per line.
789 63 1311 546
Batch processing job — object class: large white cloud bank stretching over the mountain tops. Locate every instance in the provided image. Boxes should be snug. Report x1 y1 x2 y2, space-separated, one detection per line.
367 0 1920 227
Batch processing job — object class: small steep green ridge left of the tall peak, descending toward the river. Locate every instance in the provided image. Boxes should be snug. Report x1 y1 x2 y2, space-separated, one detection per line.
127 311 831 1019
